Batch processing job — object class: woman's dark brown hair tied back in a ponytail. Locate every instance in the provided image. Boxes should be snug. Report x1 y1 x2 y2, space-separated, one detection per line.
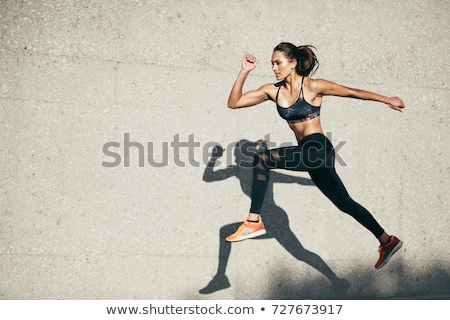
273 42 319 76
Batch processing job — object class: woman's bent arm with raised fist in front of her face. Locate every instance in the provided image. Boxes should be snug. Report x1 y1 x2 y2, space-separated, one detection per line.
227 55 269 109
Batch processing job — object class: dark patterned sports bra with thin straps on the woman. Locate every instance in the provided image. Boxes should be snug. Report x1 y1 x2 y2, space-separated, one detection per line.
275 77 320 124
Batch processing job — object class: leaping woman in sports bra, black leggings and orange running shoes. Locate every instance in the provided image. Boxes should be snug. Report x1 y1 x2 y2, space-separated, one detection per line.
226 42 405 269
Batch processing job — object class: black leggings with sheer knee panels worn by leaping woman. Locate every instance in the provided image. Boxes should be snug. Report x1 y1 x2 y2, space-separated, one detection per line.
250 133 384 238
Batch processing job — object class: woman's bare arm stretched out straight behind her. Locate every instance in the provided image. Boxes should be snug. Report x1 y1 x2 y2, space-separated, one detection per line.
311 79 405 112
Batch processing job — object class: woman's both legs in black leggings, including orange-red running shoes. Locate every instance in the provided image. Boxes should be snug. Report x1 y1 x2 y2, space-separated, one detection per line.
227 134 402 269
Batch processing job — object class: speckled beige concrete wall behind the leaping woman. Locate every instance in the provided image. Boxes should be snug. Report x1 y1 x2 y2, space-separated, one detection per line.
0 0 450 299
